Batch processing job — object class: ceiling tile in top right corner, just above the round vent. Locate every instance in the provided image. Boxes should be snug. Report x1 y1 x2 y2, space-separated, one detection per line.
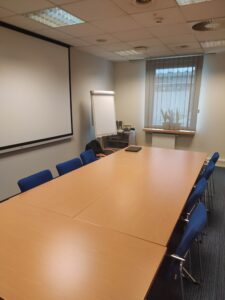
180 0 225 21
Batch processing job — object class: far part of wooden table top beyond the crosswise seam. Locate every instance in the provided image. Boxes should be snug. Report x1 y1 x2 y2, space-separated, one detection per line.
13 147 206 232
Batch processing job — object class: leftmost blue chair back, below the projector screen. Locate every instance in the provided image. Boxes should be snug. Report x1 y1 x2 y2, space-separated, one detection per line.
17 170 53 192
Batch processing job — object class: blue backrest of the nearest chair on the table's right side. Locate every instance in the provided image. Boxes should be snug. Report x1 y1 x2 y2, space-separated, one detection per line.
175 202 207 257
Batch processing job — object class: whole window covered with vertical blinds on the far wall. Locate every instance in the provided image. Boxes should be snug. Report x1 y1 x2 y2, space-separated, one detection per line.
146 56 203 130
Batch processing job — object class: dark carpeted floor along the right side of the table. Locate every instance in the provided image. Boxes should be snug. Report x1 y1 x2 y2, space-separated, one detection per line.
147 167 225 300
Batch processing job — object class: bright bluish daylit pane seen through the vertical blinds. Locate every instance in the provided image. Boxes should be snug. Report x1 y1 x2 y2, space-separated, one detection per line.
153 67 195 127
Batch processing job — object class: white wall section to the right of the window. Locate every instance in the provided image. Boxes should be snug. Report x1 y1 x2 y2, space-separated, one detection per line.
177 53 225 159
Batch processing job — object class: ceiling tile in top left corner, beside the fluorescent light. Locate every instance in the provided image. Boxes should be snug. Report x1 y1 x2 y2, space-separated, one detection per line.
0 0 53 13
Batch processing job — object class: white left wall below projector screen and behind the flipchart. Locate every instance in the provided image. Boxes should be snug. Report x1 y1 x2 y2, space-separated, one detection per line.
0 49 113 200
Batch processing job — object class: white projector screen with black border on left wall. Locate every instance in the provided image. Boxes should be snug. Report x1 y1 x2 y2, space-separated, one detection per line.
0 24 73 152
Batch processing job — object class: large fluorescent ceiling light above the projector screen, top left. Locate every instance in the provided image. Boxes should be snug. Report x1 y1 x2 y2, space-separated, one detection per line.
24 7 84 27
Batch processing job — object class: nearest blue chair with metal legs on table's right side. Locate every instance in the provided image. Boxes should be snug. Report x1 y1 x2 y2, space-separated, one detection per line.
169 202 207 299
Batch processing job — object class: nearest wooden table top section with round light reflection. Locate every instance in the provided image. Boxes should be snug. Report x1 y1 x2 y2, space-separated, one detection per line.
0 201 166 300
